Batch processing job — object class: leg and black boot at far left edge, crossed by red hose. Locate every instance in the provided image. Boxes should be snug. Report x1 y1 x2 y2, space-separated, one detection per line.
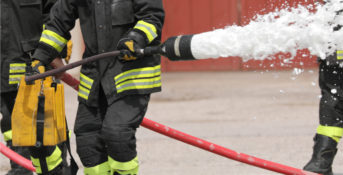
0 91 33 175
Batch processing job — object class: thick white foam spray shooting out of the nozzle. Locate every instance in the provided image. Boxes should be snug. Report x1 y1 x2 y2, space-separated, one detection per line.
191 0 343 61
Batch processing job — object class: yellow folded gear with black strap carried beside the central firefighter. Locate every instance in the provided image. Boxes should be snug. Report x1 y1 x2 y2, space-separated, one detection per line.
12 61 67 146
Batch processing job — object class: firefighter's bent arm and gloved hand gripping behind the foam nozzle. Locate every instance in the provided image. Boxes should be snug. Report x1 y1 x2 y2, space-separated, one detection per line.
117 0 164 61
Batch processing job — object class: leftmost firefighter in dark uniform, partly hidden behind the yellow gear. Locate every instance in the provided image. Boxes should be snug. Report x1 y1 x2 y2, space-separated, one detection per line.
0 0 71 175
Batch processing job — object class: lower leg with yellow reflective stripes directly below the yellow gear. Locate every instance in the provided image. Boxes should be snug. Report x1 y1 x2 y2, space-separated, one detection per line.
30 143 66 175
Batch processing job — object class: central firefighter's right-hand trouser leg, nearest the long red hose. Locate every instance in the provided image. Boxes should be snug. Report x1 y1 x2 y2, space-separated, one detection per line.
101 95 150 175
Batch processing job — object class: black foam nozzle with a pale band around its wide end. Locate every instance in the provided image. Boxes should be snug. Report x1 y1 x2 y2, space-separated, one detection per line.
137 35 196 61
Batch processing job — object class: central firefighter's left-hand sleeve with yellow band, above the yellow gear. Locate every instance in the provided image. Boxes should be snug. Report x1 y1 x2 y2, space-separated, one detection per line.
33 0 78 65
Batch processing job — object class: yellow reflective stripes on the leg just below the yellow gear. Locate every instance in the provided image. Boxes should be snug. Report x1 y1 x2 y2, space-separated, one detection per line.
31 146 62 174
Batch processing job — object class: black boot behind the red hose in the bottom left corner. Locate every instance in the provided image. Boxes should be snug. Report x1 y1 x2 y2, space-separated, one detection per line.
6 141 33 175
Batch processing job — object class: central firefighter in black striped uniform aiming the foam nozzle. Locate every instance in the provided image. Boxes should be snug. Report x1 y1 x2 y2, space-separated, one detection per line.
34 0 164 175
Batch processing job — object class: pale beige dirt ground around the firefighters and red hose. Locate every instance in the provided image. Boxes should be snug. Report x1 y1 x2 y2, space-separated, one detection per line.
0 69 343 175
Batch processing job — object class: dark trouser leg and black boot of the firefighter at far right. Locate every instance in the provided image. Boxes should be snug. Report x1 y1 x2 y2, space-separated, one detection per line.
304 61 343 175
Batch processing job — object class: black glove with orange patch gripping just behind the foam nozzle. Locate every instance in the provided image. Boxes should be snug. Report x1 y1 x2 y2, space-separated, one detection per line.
117 31 147 62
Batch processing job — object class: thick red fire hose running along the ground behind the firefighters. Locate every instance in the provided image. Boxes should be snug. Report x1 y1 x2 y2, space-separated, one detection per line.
0 73 319 175
